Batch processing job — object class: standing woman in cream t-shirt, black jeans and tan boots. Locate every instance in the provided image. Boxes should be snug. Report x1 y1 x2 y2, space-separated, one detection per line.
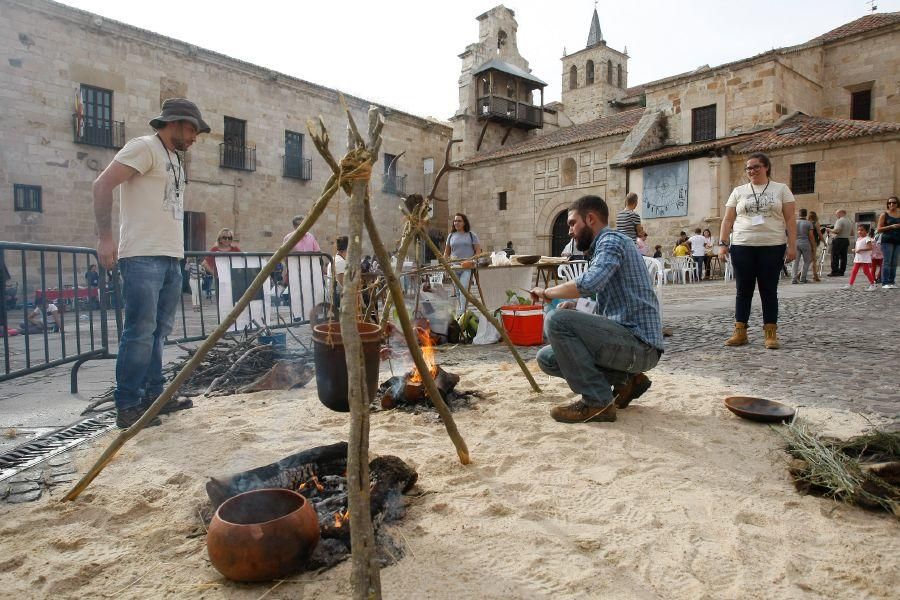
719 152 797 350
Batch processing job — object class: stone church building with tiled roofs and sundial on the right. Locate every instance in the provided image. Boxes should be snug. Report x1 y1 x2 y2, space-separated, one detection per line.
450 6 900 254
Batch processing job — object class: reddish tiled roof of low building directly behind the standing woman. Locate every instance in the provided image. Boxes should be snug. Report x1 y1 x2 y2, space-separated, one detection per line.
732 113 900 154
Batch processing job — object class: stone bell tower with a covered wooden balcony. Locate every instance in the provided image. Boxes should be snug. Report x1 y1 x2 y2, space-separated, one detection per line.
450 5 547 160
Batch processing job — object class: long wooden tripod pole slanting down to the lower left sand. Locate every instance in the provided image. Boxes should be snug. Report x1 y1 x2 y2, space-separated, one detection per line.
63 120 340 500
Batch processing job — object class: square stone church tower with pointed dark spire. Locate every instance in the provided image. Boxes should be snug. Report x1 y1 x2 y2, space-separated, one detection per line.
562 6 628 124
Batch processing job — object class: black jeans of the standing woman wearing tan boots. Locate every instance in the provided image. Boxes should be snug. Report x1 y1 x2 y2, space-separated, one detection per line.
731 244 787 324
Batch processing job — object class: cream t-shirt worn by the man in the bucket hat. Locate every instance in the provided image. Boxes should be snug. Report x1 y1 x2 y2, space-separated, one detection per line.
113 135 185 258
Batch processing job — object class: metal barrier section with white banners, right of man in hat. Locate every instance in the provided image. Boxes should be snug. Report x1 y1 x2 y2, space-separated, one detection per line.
166 252 333 344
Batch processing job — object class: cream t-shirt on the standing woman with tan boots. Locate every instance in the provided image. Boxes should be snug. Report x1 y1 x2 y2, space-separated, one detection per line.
725 181 794 246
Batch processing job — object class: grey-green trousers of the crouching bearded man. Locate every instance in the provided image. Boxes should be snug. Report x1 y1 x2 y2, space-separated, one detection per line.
537 310 660 406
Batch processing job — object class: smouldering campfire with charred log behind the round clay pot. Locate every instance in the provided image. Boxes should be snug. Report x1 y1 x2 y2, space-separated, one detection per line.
206 442 418 569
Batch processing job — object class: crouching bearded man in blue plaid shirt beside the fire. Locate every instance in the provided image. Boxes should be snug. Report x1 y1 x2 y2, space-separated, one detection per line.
531 196 663 423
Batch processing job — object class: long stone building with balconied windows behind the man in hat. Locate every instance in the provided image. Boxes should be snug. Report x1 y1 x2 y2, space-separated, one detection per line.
0 0 451 260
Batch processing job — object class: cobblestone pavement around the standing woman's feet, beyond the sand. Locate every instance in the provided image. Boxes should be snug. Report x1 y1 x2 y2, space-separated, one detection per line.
657 282 900 429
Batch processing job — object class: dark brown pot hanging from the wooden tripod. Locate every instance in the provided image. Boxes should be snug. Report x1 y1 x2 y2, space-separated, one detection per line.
313 321 381 412
